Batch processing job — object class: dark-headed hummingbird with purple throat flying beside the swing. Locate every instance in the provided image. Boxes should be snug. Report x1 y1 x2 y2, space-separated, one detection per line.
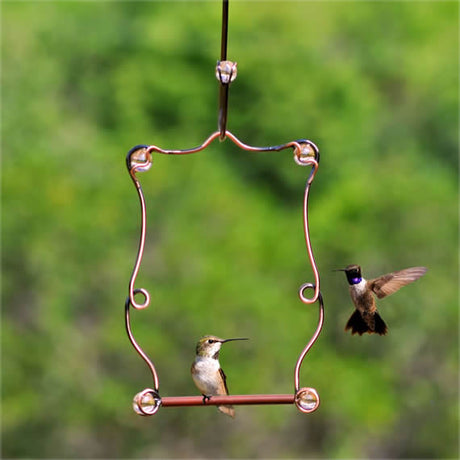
336 265 427 335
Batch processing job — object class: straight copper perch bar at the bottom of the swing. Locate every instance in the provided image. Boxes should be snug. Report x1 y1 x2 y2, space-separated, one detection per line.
161 394 295 407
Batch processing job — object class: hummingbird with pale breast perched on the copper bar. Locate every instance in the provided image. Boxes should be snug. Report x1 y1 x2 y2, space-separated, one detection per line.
191 335 248 417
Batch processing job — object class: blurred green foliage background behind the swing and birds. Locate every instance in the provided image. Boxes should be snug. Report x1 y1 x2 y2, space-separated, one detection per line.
1 1 459 458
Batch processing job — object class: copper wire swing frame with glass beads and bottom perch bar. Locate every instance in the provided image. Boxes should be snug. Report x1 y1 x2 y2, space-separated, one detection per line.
125 131 324 415
